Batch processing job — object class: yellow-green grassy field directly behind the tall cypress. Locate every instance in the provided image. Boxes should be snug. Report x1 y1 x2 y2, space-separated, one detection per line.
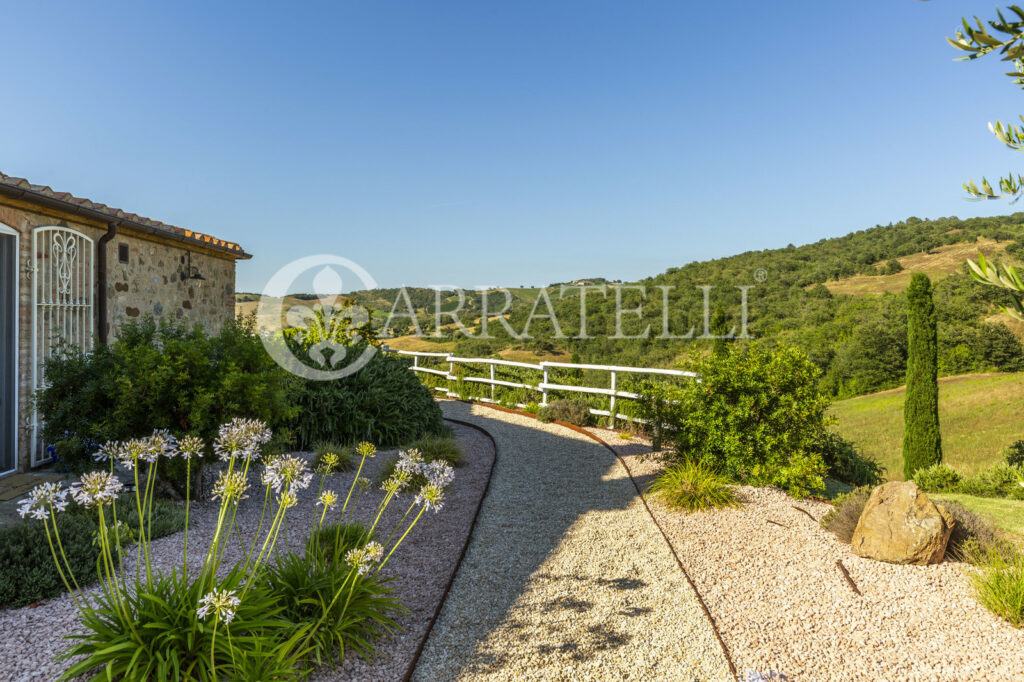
833 374 1024 480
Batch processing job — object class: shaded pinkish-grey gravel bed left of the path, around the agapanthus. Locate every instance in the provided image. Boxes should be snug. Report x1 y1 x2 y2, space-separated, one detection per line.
0 425 494 682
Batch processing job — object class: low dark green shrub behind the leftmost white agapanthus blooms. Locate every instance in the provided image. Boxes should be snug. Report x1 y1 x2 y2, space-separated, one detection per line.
0 497 184 606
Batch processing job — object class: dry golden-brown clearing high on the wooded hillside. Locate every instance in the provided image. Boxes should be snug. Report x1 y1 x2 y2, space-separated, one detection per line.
825 239 1005 296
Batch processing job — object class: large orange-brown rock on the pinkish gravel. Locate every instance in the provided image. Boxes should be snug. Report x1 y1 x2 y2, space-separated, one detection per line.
851 481 955 564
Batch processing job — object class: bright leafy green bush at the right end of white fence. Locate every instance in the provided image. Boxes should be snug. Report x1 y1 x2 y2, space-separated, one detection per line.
642 342 829 497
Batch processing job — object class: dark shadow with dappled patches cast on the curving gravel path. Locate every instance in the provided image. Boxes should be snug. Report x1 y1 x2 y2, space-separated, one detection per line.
413 401 652 680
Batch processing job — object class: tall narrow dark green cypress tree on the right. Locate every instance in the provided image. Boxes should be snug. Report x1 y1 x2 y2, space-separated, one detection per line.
903 272 942 480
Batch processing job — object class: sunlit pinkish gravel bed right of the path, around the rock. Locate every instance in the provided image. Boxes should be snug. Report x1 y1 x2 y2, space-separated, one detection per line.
592 429 1024 681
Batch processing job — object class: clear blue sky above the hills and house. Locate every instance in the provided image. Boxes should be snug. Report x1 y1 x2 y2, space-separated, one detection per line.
0 0 1024 291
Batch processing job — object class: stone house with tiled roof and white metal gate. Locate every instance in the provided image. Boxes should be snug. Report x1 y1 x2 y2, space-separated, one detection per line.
0 173 251 475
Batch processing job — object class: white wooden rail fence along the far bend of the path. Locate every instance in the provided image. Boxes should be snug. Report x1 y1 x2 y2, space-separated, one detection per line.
382 346 697 426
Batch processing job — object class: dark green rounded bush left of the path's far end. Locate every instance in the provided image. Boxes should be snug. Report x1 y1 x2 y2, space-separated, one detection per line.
291 351 445 450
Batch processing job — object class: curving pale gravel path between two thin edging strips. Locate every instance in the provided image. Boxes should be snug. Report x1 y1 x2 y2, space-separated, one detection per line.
413 402 730 681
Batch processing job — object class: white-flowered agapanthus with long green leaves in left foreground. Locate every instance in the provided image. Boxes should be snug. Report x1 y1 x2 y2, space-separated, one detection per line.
19 419 453 681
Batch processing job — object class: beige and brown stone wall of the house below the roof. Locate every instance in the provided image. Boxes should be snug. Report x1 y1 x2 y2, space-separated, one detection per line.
0 200 241 470
